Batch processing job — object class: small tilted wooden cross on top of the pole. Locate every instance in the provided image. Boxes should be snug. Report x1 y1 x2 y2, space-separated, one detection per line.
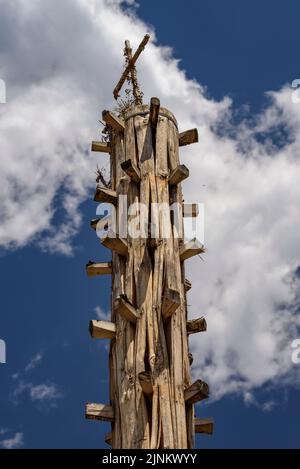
113 34 150 104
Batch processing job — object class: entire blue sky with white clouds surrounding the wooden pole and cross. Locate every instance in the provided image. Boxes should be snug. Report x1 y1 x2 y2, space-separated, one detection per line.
0 0 300 448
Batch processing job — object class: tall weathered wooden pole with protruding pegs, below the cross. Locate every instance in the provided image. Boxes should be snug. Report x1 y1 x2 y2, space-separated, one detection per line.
86 35 213 449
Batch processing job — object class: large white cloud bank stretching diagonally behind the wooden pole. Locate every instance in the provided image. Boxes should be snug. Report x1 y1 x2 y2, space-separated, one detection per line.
0 0 300 406
